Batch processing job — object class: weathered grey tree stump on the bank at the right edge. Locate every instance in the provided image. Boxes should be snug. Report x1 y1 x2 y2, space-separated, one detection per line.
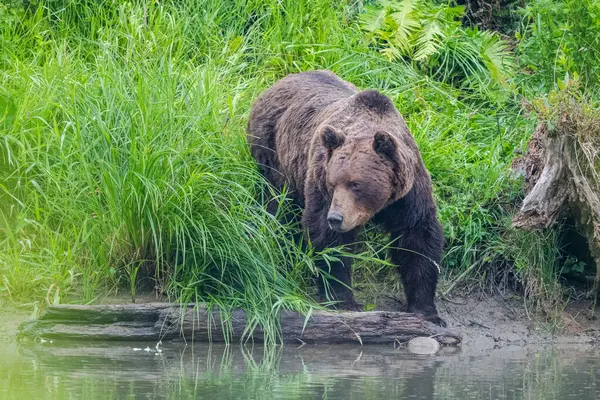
513 94 600 296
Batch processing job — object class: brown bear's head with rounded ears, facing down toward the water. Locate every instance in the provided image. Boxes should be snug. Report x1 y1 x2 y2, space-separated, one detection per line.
319 92 416 232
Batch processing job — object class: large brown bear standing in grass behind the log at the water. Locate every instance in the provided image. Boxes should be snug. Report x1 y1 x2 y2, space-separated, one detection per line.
248 71 445 326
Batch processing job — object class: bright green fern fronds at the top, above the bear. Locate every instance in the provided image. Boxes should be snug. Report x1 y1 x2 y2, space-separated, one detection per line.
361 0 513 97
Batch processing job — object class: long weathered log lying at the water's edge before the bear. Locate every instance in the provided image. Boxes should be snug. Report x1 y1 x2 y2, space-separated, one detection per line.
19 303 461 346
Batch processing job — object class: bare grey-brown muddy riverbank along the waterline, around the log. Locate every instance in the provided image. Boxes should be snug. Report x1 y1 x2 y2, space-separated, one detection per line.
0 292 600 354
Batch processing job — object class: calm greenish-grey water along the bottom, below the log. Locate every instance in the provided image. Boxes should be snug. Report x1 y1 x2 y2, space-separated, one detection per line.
0 343 600 400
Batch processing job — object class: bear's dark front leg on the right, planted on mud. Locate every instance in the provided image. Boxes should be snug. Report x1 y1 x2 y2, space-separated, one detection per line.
390 217 446 326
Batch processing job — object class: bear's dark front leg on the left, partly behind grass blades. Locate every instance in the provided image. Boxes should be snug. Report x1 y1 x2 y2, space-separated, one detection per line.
302 195 363 311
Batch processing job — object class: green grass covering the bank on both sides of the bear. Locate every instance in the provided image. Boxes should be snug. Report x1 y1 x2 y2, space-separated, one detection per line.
0 0 592 338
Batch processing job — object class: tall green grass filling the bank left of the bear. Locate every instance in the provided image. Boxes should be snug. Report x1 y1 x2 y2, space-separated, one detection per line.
0 2 336 334
